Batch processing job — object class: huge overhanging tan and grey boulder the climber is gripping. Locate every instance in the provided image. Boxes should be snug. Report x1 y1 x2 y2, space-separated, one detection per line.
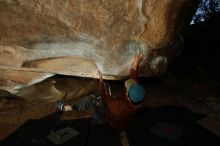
0 0 197 92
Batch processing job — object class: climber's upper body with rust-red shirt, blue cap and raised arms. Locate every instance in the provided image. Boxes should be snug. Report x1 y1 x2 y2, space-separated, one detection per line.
99 52 145 131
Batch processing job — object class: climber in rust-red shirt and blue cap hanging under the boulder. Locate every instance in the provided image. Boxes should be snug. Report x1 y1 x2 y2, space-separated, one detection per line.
57 53 145 131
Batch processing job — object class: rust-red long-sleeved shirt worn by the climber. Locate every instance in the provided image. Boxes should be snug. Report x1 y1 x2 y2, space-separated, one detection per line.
99 69 138 131
